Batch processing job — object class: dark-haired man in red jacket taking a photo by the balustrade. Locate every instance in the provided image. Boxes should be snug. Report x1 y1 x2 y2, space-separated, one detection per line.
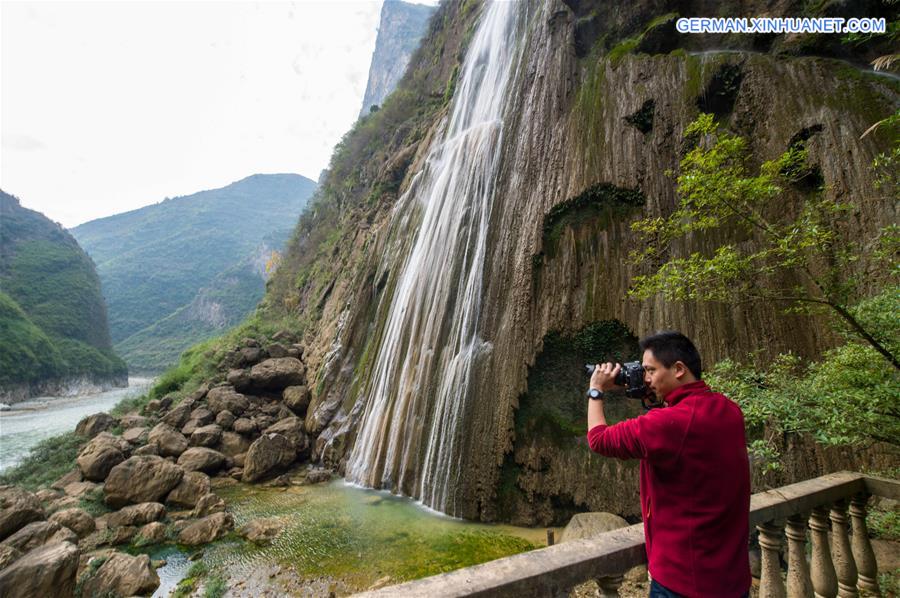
588 332 750 598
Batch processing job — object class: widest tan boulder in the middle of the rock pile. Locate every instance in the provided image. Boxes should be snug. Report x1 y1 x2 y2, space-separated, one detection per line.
103 455 184 508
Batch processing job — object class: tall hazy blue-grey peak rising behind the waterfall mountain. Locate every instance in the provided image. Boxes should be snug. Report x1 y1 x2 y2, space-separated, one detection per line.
359 0 436 116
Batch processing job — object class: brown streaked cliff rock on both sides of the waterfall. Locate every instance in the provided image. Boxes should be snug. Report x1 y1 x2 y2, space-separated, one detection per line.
258 2 900 523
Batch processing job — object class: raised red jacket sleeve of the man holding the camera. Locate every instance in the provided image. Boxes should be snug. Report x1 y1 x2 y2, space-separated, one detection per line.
588 408 693 463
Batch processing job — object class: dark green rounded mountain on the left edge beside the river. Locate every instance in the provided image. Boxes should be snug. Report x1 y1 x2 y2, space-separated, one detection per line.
0 191 128 402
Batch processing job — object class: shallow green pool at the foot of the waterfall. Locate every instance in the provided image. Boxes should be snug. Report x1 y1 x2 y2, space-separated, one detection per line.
157 480 546 595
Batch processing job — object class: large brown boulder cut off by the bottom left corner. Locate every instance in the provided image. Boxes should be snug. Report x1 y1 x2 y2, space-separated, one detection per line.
0 542 78 598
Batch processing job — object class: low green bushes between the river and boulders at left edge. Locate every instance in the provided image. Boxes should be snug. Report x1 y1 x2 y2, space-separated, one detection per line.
0 432 87 490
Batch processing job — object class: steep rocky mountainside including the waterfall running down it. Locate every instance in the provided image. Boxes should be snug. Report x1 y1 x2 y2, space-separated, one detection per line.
153 0 900 525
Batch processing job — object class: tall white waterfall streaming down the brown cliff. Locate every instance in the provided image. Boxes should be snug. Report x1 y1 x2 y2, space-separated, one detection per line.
346 1 528 513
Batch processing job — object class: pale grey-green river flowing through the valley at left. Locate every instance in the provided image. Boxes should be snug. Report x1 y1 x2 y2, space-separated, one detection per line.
0 378 153 472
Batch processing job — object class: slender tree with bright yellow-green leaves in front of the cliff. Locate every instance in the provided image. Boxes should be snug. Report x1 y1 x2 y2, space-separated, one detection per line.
631 114 900 369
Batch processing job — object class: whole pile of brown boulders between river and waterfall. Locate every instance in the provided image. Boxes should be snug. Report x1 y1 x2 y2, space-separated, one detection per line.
0 332 332 598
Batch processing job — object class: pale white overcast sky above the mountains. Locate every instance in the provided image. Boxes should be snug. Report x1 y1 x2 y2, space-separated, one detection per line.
0 0 436 227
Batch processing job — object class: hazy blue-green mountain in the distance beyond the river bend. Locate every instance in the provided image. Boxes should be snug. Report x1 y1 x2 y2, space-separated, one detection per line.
71 174 316 372
